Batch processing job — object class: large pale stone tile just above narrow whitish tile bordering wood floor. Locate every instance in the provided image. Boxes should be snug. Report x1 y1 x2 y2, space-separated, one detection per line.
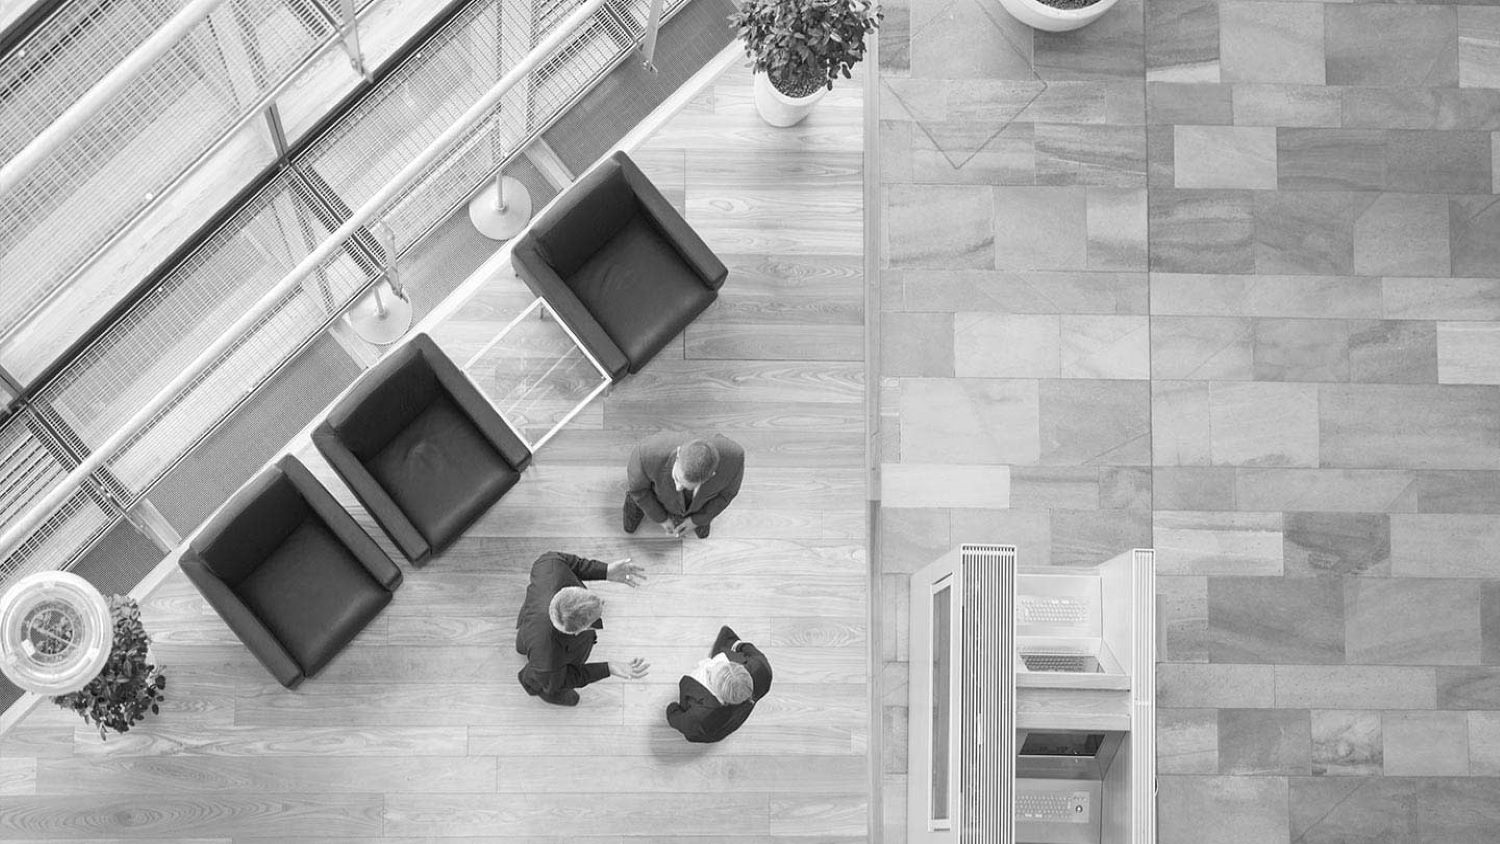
900 378 1041 463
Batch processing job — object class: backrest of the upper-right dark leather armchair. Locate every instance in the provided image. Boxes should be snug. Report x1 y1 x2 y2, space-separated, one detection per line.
531 159 641 282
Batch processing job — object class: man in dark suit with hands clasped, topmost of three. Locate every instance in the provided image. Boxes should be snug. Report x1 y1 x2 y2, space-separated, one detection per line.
624 433 746 540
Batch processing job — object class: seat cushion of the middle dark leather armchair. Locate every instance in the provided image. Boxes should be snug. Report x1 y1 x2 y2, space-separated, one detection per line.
366 396 521 549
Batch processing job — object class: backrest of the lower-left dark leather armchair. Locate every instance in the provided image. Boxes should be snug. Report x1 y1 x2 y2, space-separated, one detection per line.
192 466 312 589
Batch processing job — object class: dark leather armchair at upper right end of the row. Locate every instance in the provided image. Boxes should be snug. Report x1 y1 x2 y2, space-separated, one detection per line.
512 153 729 378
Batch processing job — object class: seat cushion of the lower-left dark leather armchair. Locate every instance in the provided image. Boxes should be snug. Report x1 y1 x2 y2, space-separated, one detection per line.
234 517 392 675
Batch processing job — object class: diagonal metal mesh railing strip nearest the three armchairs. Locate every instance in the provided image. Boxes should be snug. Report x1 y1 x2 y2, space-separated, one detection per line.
0 0 686 579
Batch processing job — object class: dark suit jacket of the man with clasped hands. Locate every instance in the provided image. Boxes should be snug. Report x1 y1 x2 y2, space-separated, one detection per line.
626 433 746 526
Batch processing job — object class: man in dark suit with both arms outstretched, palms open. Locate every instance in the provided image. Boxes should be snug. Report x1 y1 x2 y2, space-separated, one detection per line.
516 552 651 706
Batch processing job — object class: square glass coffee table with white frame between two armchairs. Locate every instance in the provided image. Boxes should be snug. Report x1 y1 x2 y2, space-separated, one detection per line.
464 298 611 453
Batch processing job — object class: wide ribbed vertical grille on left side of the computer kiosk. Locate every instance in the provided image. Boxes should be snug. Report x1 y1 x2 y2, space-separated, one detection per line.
959 544 1016 844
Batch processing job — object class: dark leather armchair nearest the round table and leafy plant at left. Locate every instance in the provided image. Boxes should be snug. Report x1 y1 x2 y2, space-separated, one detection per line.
179 456 401 688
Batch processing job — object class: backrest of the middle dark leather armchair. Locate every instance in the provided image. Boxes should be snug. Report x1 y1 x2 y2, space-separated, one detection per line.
327 342 443 460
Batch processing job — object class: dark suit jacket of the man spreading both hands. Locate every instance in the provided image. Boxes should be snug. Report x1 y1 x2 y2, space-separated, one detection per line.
516 552 609 694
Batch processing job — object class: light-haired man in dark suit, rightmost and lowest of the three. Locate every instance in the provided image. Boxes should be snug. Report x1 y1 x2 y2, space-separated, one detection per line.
666 627 771 744
